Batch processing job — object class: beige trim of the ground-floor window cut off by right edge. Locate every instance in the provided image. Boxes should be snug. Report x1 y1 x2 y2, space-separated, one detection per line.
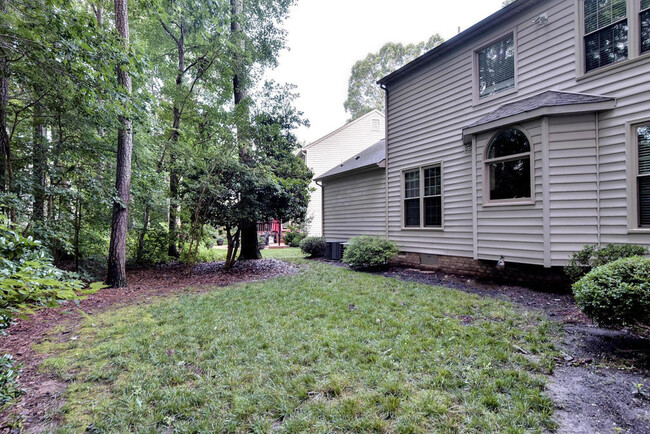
625 117 650 233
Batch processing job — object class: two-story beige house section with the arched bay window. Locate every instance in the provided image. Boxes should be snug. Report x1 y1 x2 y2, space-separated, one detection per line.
326 0 650 282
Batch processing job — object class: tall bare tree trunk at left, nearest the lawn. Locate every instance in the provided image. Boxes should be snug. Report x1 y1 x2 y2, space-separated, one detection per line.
106 0 133 288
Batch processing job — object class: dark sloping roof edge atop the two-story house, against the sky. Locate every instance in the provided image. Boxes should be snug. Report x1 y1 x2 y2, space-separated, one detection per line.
377 0 548 87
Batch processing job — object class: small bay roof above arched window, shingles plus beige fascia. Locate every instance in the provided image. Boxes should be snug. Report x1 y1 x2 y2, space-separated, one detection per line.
463 90 616 142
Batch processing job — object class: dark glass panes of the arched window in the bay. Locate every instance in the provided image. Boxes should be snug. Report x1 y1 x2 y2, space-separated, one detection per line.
485 128 531 201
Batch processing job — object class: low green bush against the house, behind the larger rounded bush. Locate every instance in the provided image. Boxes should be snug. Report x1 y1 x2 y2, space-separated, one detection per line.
564 244 648 282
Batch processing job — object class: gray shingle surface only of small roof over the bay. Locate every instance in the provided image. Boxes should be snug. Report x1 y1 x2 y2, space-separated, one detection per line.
465 90 615 129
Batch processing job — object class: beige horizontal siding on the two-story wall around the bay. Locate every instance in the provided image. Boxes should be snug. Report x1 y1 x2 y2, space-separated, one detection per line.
387 0 650 265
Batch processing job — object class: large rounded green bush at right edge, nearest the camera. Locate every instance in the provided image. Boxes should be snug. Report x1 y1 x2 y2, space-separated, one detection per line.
573 256 650 326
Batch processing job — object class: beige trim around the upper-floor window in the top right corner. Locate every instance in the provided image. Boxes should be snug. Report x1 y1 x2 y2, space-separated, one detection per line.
575 0 650 79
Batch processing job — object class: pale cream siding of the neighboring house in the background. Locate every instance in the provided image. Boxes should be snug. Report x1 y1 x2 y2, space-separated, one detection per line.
305 110 385 236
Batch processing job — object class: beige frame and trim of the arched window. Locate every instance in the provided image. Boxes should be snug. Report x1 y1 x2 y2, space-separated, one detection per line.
481 125 535 208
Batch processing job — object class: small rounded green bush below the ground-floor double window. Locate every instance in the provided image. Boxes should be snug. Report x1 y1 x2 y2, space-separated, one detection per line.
343 235 398 270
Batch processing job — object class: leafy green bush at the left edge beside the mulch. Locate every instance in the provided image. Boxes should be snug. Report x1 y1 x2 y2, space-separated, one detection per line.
0 216 87 328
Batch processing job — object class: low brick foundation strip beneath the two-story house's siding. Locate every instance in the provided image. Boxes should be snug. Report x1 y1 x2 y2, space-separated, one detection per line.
392 252 570 291
